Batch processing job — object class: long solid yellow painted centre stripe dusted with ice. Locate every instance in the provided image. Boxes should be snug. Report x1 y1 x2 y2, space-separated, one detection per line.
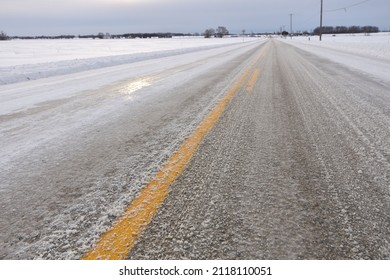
82 68 251 260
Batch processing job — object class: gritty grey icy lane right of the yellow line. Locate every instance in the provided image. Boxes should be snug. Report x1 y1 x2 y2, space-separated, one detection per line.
128 40 390 259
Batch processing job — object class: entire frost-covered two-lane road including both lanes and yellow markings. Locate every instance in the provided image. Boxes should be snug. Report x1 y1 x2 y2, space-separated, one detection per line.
0 39 390 259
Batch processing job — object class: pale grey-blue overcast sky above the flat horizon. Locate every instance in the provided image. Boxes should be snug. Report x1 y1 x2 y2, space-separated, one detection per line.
0 0 390 36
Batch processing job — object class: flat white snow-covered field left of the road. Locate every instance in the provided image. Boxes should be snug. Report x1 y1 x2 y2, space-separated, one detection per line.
0 37 253 85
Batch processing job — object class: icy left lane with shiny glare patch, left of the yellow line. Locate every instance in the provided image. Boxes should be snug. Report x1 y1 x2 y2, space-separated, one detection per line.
0 40 264 259
